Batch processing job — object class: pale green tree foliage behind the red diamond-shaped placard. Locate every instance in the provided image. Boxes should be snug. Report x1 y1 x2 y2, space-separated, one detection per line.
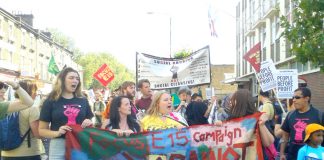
76 52 135 89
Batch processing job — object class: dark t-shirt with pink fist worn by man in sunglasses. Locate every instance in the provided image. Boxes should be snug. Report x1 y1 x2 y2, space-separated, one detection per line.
281 106 323 159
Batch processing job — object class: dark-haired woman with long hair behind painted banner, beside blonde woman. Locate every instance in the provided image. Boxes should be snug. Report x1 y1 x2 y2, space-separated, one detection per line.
107 96 140 136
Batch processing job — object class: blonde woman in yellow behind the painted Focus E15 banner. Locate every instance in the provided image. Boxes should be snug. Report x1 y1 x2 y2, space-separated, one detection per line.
141 91 188 131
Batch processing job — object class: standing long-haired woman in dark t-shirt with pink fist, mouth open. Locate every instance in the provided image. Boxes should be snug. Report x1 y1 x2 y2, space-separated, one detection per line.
39 67 93 160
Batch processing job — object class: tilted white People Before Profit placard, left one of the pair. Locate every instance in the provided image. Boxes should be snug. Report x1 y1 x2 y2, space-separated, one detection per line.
257 59 277 92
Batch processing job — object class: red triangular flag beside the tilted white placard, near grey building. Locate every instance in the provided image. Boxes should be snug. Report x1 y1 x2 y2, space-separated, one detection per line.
243 42 261 73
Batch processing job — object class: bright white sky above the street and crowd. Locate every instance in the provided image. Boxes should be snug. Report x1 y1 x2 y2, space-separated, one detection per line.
0 0 238 71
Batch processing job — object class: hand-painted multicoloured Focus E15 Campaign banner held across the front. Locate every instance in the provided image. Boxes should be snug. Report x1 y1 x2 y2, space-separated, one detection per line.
66 113 263 160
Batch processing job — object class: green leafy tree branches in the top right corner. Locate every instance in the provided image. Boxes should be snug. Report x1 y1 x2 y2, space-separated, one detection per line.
280 0 324 72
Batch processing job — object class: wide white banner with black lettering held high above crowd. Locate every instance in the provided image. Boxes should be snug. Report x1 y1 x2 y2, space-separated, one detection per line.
136 46 210 89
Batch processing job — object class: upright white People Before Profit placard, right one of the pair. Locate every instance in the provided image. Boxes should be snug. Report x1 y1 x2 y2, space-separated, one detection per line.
276 69 298 98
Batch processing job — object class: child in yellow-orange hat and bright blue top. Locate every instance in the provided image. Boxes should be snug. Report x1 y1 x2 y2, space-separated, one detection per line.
297 123 324 160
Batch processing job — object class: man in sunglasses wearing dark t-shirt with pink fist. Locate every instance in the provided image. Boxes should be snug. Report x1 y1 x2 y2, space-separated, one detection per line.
280 88 323 160
